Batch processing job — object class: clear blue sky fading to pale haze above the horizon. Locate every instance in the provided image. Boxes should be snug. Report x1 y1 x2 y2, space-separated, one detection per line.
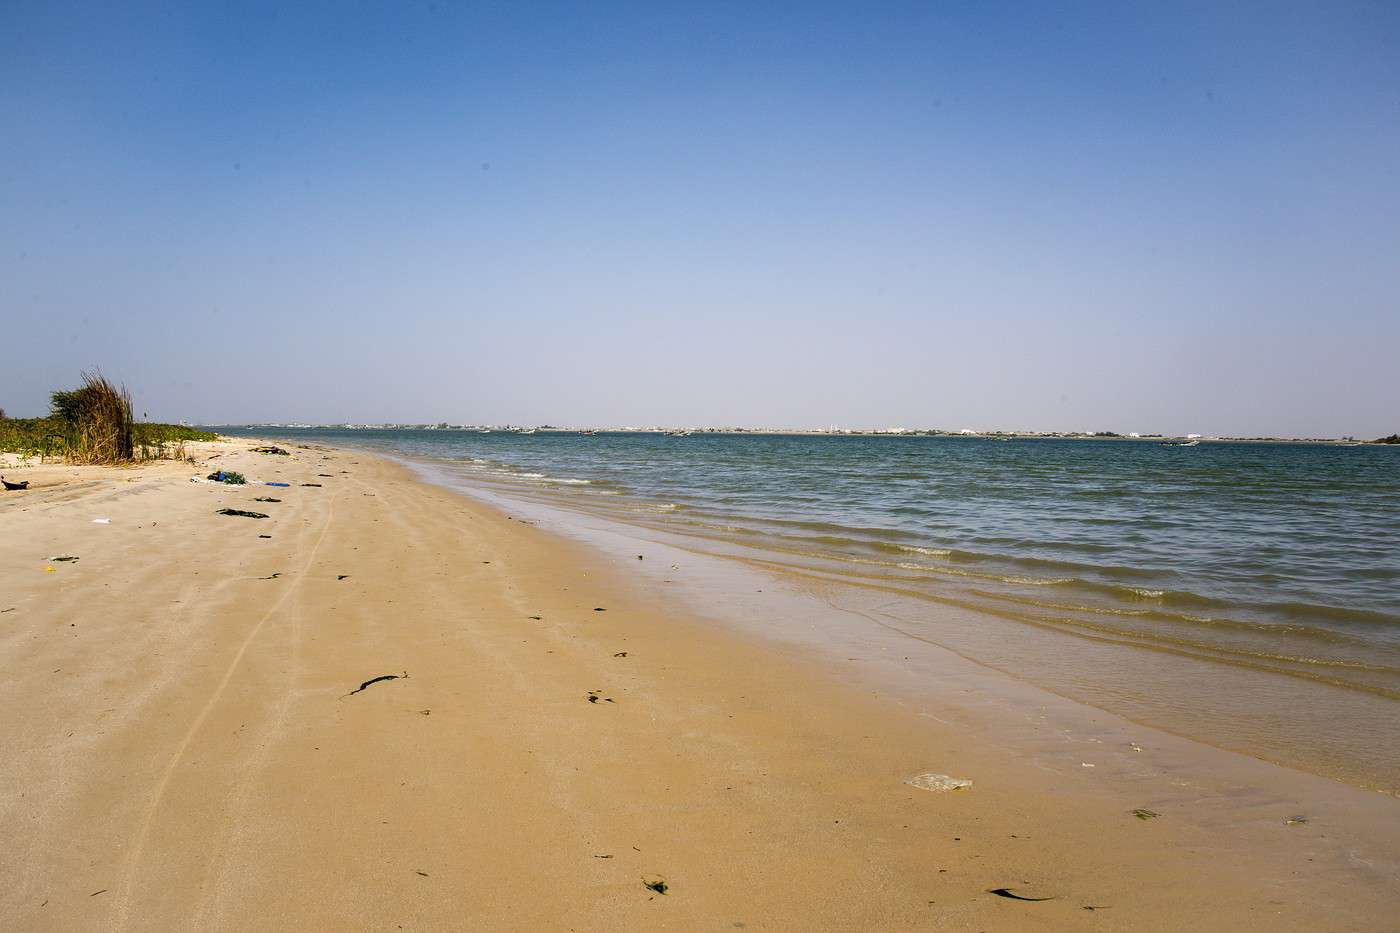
0 0 1400 436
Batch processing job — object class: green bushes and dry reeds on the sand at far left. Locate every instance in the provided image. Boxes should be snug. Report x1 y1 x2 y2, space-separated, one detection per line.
0 373 217 464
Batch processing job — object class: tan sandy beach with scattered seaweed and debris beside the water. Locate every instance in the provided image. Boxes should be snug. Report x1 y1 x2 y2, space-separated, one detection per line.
0 441 1400 930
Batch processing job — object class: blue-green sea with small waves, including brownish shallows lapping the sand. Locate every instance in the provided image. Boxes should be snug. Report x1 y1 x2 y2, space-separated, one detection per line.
220 427 1400 792
